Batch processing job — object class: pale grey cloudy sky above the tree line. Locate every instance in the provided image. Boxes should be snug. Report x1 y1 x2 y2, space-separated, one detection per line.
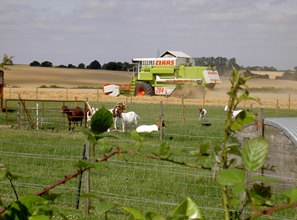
0 0 297 70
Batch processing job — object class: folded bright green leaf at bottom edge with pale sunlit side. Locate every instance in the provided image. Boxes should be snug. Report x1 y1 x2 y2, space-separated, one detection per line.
169 198 203 219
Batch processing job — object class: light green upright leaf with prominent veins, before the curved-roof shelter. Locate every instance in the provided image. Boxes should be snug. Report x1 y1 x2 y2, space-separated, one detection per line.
242 137 269 172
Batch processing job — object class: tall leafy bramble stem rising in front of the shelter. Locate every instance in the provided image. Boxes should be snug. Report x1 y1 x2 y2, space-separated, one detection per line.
215 69 295 220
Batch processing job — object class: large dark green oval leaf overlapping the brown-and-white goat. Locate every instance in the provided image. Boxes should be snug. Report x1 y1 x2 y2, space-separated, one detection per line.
91 107 113 134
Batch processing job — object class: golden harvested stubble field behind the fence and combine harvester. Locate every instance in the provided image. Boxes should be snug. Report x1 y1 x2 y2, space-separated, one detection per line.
4 65 297 109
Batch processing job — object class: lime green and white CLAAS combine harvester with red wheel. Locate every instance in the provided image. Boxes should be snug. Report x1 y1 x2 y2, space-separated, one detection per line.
104 51 221 96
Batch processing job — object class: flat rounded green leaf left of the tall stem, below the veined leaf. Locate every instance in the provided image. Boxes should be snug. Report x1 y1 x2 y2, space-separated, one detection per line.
217 168 245 186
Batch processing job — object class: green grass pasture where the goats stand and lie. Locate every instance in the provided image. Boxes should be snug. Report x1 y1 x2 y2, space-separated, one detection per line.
0 101 297 219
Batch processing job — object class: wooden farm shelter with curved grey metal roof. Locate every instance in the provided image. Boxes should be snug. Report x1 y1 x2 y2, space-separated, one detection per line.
237 117 297 188
